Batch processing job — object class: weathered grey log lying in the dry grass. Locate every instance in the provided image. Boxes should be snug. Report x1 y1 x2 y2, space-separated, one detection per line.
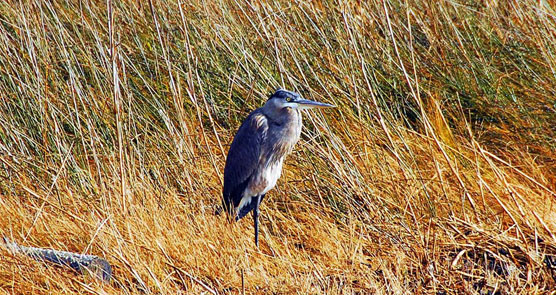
3 237 112 283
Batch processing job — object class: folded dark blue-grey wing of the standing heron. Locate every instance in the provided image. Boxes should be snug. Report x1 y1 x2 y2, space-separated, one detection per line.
223 111 268 213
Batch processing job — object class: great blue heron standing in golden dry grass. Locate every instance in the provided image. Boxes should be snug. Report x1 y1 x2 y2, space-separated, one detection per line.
223 88 334 247
